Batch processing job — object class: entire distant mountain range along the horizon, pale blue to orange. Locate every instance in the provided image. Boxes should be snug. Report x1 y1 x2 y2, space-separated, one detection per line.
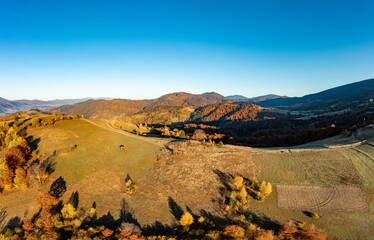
0 79 374 119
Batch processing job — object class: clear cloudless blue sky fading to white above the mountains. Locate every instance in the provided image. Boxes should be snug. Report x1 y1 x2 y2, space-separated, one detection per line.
0 0 374 100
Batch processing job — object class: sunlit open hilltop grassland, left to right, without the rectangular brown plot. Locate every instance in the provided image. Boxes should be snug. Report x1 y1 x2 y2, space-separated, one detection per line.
0 120 374 239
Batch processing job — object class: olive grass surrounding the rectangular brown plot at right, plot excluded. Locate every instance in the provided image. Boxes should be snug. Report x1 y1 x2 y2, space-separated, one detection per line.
252 147 374 239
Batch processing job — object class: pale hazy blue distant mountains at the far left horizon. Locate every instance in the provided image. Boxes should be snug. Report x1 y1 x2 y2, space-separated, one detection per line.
0 97 89 114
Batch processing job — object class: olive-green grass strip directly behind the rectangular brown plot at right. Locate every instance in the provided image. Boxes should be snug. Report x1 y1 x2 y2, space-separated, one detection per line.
252 149 362 185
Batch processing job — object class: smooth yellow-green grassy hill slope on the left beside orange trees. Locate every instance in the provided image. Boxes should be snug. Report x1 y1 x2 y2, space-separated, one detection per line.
0 120 159 222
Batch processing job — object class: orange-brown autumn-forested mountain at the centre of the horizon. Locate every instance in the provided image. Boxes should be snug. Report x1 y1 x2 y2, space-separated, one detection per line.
51 92 225 119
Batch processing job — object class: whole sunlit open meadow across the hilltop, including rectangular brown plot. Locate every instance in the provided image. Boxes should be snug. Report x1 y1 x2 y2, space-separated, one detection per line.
0 119 374 239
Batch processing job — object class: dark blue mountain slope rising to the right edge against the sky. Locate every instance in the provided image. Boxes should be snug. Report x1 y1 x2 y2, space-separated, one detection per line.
258 79 374 111
